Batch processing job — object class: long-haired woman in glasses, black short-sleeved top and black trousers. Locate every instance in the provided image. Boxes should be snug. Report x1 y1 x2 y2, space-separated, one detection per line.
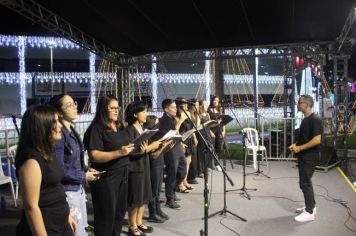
84 96 133 236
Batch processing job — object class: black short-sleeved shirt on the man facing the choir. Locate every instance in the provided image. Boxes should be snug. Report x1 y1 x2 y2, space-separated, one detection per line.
296 113 323 156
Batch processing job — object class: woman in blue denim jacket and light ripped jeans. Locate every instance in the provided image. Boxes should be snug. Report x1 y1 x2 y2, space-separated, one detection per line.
50 94 100 236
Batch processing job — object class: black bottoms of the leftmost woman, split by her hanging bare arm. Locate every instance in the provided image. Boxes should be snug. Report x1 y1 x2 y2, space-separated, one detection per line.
16 202 74 236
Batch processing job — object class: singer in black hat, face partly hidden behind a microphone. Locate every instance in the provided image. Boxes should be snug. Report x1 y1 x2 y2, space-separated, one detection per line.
176 97 194 193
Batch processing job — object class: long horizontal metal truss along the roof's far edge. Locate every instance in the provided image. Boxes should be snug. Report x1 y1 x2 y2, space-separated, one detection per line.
131 41 334 64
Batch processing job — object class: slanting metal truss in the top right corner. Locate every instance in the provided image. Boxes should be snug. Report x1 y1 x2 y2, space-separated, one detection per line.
336 1 356 54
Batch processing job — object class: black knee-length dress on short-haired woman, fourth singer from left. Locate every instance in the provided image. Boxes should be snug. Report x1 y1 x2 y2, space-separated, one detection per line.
126 125 152 207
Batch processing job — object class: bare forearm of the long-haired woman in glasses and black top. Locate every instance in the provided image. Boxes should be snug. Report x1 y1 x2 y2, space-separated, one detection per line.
88 144 134 163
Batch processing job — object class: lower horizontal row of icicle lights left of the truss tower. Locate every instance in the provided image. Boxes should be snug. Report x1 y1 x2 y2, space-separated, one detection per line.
0 72 116 84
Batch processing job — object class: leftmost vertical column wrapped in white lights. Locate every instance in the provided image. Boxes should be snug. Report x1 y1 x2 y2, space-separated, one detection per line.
17 36 27 115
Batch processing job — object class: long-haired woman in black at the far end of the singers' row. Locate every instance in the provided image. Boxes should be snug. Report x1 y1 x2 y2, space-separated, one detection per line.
209 96 226 153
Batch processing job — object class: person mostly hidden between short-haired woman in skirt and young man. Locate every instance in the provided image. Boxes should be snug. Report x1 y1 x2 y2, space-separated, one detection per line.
144 116 174 223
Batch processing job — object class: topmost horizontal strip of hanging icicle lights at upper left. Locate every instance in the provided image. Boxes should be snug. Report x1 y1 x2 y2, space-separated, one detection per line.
0 35 81 49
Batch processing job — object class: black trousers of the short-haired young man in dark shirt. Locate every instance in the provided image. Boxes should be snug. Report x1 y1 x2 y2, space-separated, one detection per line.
164 153 186 202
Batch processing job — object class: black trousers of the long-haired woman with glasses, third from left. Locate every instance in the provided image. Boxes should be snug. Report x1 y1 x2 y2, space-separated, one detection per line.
91 167 128 236
